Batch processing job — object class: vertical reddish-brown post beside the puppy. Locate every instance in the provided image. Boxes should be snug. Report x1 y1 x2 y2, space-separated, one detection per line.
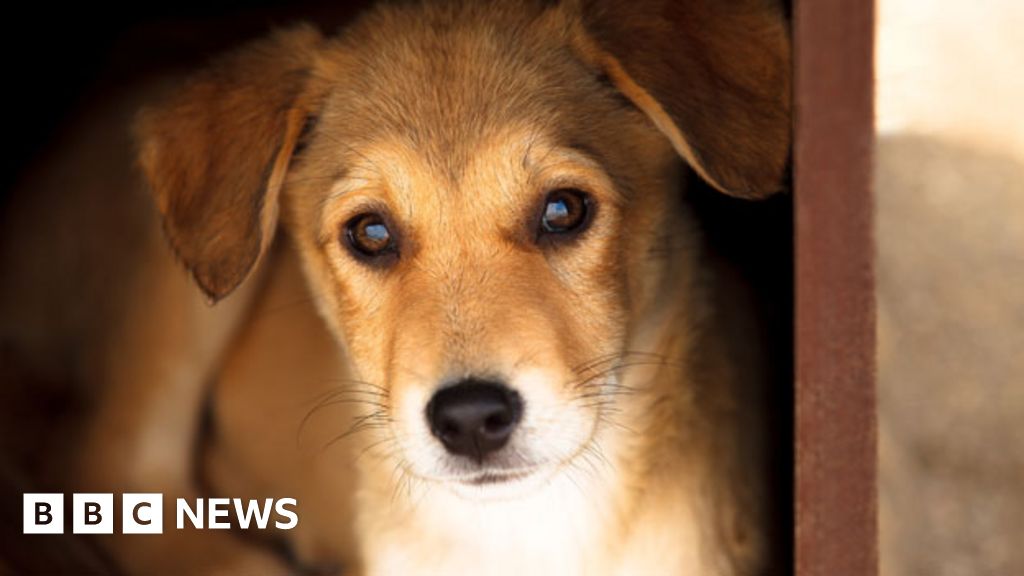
794 0 878 576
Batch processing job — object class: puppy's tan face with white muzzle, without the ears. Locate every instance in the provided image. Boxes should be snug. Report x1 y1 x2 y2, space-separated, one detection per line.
285 5 690 484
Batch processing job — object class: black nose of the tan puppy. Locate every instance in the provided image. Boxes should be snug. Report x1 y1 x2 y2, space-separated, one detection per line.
427 378 522 462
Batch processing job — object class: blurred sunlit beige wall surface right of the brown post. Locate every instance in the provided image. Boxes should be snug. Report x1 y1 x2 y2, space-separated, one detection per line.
876 0 1024 576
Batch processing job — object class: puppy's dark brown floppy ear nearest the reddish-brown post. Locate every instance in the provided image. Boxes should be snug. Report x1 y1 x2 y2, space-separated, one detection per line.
575 0 792 198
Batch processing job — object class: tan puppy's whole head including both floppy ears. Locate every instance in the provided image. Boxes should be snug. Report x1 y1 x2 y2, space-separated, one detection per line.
136 3 787 494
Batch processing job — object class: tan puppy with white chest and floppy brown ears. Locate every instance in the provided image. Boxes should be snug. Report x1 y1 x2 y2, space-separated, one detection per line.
5 0 790 575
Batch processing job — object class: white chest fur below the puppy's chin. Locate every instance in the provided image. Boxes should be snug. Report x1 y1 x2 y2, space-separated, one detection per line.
362 461 714 576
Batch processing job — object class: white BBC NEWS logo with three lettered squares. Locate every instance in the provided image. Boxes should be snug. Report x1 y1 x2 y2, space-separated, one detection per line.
22 493 299 534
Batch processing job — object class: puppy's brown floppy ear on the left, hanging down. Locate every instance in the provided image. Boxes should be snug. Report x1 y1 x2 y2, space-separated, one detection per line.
136 26 321 301
